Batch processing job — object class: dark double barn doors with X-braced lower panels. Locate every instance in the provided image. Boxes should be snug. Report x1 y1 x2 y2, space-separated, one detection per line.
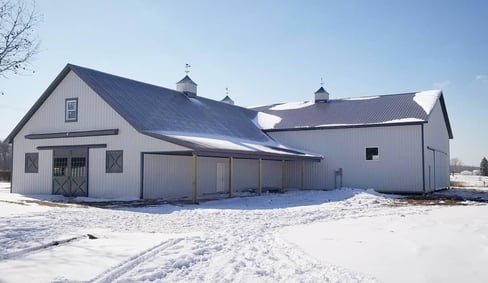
53 147 88 197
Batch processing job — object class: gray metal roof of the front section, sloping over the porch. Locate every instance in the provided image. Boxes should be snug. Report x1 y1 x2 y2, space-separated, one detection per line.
7 64 321 162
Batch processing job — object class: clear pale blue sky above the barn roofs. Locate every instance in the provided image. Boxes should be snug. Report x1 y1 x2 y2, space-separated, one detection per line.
0 0 488 165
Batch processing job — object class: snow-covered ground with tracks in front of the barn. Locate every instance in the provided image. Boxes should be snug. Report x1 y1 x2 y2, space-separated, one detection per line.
0 178 488 282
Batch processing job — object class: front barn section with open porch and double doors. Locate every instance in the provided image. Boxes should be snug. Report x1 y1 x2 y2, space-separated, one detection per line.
7 64 322 202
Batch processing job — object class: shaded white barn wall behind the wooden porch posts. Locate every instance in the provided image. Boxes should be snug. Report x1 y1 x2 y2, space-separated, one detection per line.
144 156 301 199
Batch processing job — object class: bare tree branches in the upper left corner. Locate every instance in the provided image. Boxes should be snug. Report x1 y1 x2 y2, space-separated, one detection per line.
0 0 41 77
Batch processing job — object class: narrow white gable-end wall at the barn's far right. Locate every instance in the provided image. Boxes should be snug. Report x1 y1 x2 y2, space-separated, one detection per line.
424 101 449 191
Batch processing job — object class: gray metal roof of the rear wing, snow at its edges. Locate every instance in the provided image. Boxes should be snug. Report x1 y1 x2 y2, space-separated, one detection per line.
252 91 452 138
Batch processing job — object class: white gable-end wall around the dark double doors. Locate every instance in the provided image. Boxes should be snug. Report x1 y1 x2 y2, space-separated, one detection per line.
12 72 185 198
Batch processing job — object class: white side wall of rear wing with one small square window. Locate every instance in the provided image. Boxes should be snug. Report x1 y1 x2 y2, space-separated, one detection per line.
269 125 423 192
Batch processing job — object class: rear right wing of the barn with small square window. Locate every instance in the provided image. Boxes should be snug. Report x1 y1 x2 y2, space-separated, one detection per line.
254 87 453 193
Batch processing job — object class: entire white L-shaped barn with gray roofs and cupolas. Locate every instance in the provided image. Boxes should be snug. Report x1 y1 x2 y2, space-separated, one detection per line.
7 64 452 202
